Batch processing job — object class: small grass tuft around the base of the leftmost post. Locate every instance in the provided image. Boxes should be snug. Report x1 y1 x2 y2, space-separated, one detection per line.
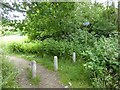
26 68 40 85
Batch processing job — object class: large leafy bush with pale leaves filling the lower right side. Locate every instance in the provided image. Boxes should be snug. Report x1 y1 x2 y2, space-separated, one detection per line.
83 37 120 88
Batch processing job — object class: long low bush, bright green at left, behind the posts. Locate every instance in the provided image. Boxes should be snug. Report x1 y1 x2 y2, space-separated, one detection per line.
8 39 73 56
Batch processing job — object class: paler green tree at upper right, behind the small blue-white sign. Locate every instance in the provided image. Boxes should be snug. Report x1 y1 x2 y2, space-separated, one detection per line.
77 2 117 37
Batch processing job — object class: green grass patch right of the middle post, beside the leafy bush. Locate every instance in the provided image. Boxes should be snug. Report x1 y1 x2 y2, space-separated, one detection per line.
59 60 90 88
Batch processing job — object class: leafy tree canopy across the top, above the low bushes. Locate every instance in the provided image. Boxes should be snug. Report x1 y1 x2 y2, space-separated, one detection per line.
17 2 117 40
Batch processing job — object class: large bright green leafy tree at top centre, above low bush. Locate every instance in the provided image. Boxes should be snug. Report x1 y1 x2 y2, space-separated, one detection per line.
19 2 77 40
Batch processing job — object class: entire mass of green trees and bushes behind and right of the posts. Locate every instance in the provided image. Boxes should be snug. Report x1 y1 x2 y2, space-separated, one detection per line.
0 2 120 88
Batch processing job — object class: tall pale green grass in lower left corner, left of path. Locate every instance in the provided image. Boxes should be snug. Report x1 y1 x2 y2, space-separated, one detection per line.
0 53 19 89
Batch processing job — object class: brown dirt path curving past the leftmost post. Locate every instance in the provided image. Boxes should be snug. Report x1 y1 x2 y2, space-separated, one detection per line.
8 56 64 88
